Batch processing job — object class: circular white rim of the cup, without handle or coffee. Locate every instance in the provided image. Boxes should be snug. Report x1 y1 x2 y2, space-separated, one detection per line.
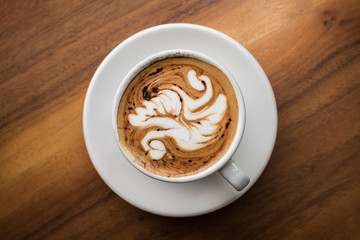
112 49 246 182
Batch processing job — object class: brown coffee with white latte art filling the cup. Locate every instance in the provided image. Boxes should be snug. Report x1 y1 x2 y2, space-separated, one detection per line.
117 57 239 177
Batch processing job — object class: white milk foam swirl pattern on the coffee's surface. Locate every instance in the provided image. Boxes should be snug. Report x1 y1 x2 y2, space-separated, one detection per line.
128 70 227 160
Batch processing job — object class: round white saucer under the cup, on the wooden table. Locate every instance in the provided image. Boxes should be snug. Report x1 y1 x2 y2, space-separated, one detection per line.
83 24 277 217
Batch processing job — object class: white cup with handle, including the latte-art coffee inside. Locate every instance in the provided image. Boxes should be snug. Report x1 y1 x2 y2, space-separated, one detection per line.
112 49 250 191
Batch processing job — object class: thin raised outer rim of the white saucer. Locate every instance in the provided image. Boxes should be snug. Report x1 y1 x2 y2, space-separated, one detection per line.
83 23 278 217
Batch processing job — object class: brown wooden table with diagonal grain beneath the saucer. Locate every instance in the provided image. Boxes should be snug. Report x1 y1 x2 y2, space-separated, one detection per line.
0 0 360 239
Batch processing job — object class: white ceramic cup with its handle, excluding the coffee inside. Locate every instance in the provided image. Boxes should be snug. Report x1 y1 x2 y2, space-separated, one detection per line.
112 49 250 191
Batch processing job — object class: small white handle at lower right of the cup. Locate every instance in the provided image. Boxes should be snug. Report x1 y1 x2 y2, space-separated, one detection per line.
219 159 250 191
